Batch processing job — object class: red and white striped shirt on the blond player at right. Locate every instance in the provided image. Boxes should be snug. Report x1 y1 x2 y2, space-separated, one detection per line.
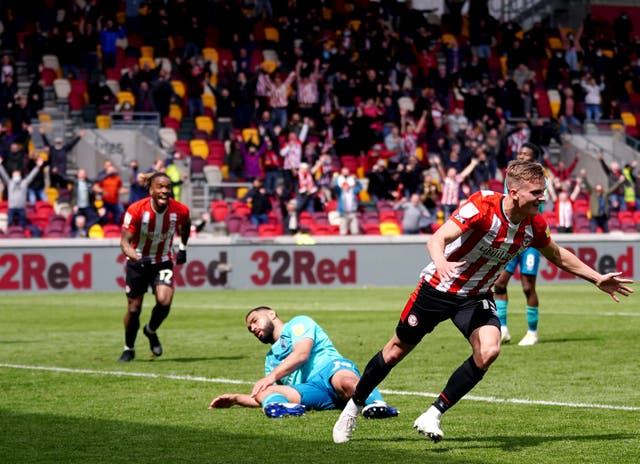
421 190 551 296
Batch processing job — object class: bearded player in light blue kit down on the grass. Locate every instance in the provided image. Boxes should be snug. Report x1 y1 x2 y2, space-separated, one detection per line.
209 306 398 419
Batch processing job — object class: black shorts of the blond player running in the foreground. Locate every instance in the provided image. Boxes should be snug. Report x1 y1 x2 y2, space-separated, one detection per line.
396 281 500 345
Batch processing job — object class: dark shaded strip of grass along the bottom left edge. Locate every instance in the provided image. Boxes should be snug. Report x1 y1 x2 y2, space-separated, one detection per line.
0 408 483 464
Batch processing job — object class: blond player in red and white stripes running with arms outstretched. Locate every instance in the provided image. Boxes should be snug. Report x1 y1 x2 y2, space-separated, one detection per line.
333 160 633 443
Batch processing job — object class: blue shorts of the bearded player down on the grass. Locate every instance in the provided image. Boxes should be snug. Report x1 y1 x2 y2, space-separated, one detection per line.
290 358 382 411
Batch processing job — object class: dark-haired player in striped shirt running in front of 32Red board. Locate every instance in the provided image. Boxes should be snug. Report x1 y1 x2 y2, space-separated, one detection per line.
119 172 191 362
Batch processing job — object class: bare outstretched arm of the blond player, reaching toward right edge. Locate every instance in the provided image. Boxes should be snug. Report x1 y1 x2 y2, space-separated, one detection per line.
540 240 633 302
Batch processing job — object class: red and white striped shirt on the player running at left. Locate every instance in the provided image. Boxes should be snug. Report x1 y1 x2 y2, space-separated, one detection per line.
122 198 189 263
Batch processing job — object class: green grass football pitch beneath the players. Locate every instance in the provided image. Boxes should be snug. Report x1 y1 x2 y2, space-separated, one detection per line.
0 282 640 464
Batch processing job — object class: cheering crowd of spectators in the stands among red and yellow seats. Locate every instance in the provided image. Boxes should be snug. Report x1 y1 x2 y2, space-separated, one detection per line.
0 0 640 236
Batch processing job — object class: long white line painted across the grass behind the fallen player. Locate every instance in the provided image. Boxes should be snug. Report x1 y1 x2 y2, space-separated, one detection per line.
0 363 640 411
